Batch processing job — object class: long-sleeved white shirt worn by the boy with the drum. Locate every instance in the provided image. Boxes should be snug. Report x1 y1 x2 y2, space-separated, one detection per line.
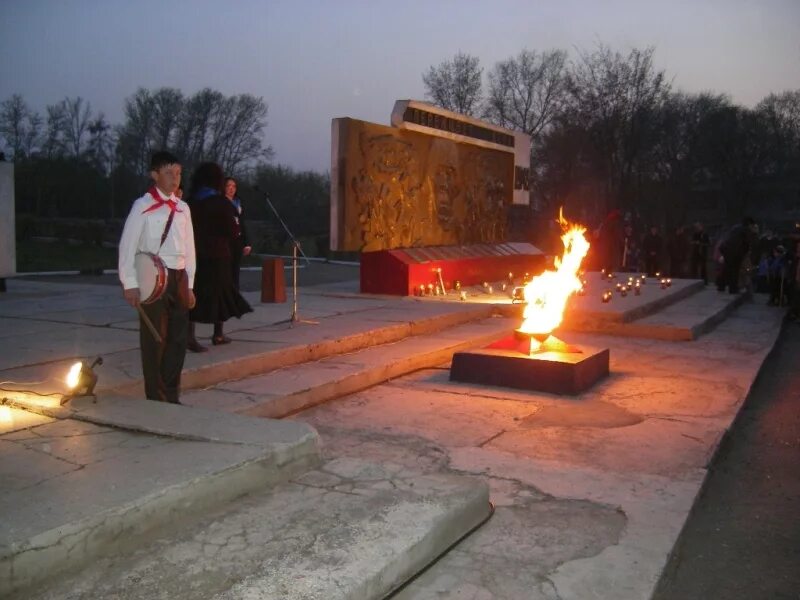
119 190 196 290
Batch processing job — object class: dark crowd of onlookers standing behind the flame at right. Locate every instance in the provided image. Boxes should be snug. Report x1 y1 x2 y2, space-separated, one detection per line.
588 210 800 319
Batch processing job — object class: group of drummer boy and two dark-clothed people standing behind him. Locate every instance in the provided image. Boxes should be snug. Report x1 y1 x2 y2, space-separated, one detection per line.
119 151 252 404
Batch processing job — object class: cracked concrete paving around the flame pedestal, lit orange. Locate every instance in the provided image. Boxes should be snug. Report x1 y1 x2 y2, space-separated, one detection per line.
286 304 780 600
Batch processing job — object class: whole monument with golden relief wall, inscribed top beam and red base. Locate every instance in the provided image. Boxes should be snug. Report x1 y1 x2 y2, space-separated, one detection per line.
331 100 544 295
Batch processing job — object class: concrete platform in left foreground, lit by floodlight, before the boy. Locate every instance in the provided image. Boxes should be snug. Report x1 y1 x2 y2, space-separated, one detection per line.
0 398 320 597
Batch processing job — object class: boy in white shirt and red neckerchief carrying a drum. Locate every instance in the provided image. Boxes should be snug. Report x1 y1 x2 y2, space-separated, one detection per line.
119 152 196 404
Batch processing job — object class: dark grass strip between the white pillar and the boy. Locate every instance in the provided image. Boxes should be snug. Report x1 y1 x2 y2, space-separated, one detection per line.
17 240 117 273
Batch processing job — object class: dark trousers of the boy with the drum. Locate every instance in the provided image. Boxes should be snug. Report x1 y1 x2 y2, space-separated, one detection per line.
139 269 189 403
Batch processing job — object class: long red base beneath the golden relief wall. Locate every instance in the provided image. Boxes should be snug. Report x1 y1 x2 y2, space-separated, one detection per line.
361 243 546 296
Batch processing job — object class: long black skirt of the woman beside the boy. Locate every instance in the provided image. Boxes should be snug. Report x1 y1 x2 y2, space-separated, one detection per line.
189 258 253 323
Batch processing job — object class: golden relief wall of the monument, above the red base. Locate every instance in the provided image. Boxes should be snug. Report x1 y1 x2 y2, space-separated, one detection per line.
331 118 514 251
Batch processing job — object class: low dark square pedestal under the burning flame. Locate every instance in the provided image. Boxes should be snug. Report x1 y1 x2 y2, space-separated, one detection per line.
450 338 610 395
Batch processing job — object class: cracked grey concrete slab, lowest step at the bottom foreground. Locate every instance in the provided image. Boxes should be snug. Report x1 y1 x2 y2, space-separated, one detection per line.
21 459 491 600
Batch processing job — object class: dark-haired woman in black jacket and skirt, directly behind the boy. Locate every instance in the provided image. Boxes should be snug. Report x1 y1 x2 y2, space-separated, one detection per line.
188 162 253 352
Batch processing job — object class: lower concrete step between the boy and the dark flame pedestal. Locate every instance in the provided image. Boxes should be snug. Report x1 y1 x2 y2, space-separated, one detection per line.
182 317 518 418
